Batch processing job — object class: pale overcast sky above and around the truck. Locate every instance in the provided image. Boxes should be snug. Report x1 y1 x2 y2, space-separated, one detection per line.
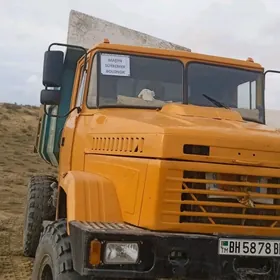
0 0 280 109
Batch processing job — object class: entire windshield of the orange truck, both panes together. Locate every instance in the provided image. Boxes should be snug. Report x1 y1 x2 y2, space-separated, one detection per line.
87 53 264 123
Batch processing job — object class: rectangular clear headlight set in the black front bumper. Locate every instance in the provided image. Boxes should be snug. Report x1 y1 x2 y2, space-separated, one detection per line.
104 242 139 264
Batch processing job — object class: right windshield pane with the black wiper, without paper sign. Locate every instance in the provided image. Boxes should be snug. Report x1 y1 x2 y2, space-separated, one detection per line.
187 62 264 122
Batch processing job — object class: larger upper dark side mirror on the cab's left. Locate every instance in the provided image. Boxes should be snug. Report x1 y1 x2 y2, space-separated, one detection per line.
43 51 64 87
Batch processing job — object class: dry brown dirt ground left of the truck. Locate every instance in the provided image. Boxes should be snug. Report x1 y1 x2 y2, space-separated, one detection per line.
0 103 54 280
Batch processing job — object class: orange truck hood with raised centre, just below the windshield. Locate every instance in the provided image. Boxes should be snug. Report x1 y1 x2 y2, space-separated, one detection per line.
90 104 280 167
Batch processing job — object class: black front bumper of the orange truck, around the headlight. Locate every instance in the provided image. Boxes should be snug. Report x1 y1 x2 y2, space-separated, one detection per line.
70 221 280 280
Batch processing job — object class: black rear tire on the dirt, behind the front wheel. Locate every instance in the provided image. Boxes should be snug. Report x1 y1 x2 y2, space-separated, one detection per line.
23 176 57 257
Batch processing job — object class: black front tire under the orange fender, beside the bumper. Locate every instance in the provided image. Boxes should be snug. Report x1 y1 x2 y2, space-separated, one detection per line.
32 219 85 280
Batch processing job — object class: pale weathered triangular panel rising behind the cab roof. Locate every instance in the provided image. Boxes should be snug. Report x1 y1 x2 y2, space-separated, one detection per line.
67 10 191 52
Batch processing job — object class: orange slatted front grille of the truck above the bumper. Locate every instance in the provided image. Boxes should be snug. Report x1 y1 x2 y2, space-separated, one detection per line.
163 171 280 228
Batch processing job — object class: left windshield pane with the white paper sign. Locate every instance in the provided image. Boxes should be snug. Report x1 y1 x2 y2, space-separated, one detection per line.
93 53 184 107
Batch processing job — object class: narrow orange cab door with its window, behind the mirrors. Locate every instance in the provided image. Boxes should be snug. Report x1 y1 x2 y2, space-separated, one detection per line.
59 61 88 178
